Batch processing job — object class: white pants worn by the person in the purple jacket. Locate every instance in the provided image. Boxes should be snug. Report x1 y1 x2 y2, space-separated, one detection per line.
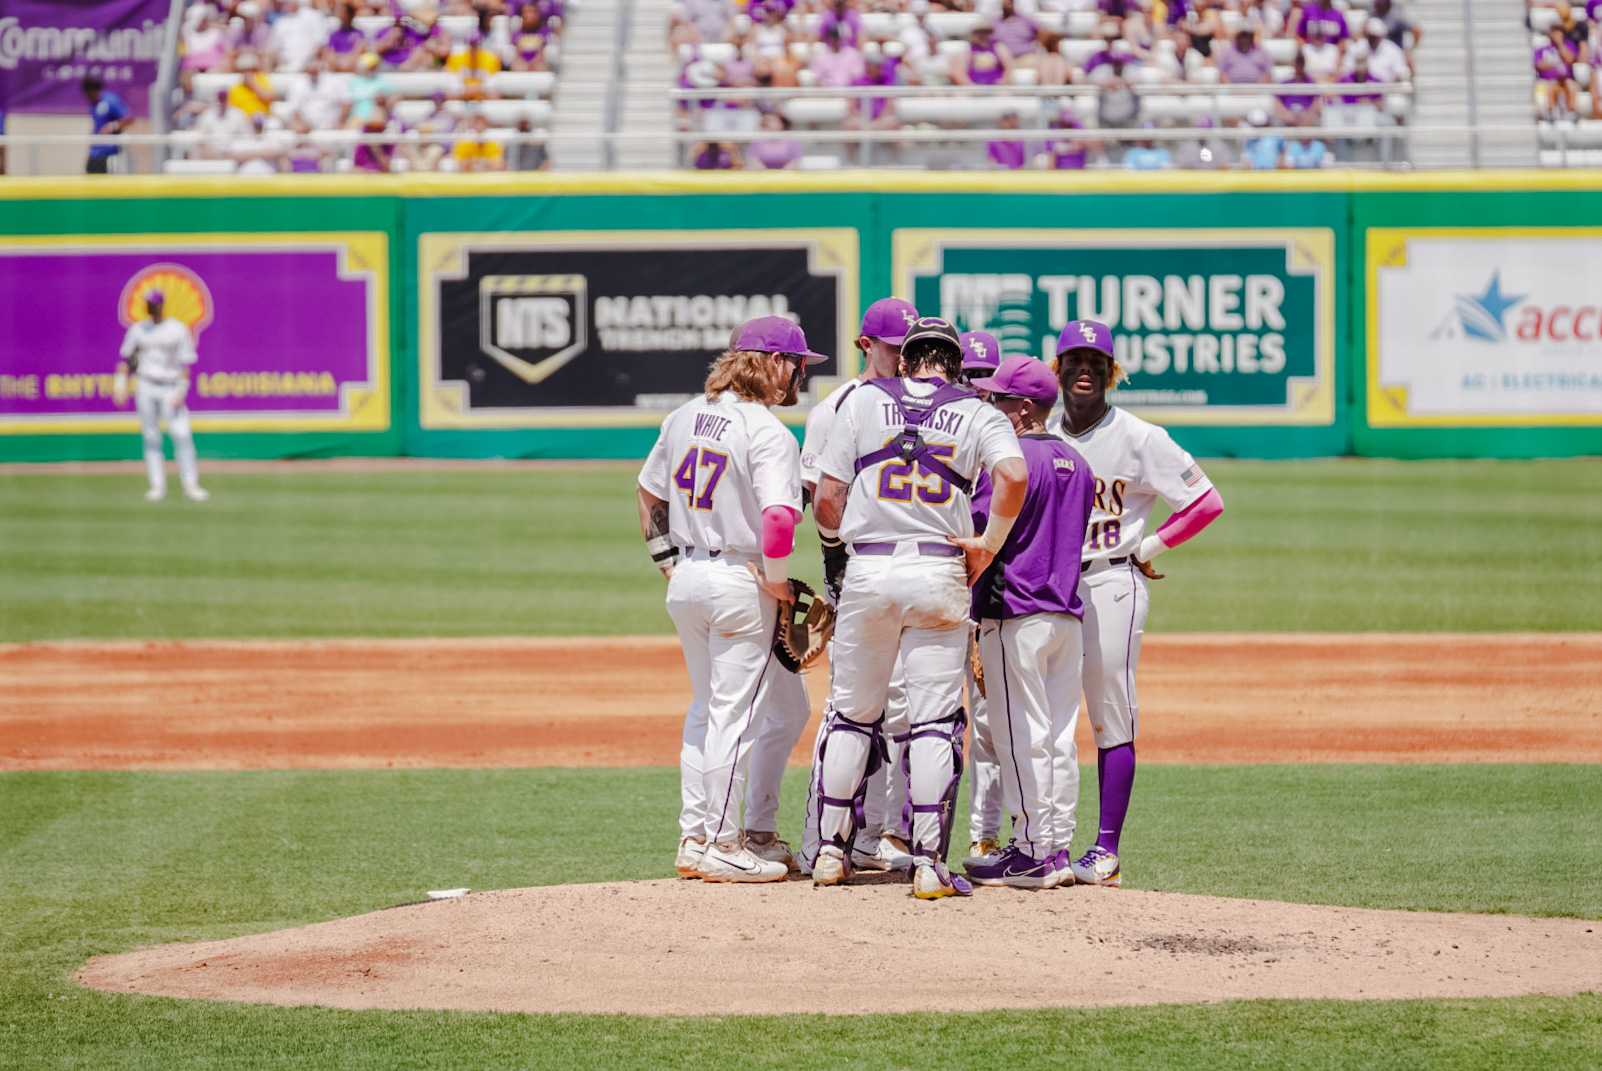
979 613 1085 860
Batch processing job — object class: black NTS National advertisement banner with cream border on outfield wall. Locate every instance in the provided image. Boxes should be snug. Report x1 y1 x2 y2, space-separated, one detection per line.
418 229 857 429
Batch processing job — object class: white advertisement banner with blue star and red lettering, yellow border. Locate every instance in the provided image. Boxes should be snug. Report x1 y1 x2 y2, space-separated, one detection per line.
1367 227 1602 427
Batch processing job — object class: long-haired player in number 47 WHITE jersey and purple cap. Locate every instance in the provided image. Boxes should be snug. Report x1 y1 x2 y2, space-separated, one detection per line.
638 315 823 882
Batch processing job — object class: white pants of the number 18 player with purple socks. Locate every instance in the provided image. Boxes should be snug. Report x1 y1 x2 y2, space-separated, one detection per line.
1080 562 1152 749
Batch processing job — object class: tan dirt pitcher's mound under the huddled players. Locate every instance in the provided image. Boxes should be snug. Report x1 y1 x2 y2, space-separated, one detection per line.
78 880 1602 1015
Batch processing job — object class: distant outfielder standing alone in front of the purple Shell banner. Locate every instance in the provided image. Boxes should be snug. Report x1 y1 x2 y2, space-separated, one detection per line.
112 290 210 503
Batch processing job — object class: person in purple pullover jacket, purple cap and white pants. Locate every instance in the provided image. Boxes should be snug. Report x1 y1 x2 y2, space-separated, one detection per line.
964 357 1094 888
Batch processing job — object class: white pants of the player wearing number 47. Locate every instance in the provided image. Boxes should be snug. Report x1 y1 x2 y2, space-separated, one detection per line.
668 549 779 844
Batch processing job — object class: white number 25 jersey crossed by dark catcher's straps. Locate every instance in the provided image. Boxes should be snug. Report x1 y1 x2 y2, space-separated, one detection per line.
819 379 1024 543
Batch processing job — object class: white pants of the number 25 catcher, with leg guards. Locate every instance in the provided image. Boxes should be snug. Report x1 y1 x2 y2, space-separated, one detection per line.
817 543 969 855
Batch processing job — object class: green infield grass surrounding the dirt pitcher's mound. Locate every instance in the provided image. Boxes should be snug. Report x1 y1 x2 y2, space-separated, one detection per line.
0 767 1602 1068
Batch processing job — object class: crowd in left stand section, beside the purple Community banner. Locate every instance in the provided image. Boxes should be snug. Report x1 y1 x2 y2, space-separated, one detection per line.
168 0 572 174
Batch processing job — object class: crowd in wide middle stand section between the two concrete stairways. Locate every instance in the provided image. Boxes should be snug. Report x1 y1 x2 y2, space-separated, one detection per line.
668 0 1422 170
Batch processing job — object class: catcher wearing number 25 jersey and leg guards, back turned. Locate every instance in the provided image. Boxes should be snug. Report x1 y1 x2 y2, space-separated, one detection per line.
812 317 1027 900
